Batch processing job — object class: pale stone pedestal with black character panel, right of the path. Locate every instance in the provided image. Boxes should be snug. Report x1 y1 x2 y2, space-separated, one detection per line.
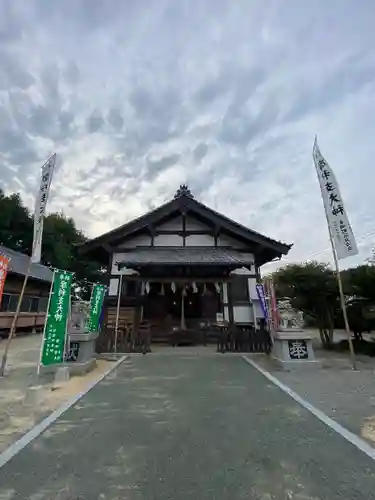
271 329 321 370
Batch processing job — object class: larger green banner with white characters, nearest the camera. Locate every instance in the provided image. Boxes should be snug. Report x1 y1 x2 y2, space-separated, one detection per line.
41 270 73 366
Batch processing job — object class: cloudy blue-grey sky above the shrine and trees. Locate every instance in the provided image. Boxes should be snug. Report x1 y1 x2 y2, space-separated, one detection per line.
0 0 375 267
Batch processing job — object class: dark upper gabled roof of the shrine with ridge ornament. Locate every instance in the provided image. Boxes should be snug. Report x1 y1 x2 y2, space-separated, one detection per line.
80 185 292 264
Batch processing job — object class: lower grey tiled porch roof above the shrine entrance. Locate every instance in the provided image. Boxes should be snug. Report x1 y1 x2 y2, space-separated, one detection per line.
118 247 253 267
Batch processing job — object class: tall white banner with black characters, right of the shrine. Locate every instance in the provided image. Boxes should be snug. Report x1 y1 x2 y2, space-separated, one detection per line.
313 137 358 260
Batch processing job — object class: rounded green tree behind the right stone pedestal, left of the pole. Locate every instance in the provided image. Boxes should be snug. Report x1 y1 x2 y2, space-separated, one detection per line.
273 262 339 347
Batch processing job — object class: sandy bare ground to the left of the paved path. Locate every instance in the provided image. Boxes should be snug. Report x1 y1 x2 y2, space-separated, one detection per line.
0 335 113 453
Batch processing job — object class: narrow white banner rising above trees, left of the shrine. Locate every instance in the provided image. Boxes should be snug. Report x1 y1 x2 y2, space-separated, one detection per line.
31 154 56 262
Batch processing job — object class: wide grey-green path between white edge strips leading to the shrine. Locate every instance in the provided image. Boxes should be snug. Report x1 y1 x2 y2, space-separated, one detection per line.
0 351 375 500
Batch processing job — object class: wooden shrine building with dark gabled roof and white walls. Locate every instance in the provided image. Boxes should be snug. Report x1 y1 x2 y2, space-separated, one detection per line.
80 185 291 349
